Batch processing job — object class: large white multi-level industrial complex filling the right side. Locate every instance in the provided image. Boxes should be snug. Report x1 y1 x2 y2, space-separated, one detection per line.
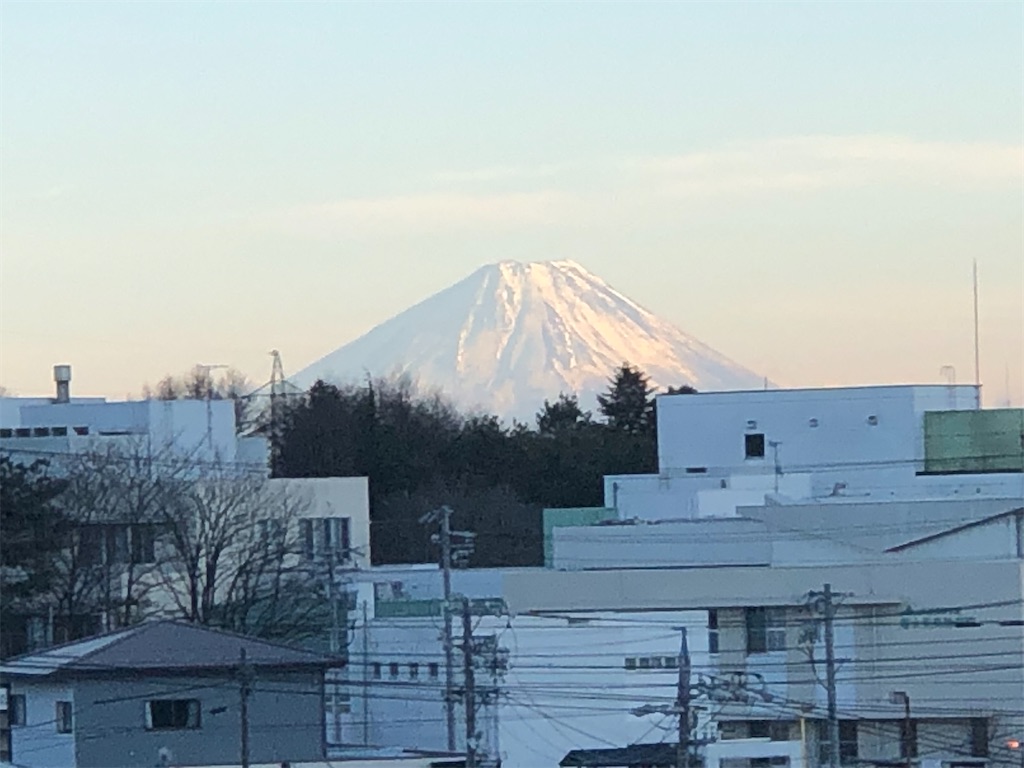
345 386 1024 768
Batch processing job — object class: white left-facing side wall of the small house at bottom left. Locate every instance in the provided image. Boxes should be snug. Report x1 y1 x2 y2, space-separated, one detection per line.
10 680 76 768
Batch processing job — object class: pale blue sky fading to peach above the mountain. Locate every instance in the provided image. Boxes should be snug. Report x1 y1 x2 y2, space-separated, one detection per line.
0 0 1024 402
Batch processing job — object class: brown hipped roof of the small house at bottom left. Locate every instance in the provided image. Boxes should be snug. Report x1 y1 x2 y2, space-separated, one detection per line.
0 621 338 676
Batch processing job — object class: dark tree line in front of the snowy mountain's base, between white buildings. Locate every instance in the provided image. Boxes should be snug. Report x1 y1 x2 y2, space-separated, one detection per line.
271 364 696 566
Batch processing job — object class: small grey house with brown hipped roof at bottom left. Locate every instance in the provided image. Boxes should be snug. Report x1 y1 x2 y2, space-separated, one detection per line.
0 622 336 768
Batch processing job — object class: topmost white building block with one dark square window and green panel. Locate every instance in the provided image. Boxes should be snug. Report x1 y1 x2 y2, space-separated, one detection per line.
604 385 1024 520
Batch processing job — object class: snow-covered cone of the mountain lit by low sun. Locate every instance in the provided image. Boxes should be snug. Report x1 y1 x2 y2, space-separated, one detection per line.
293 261 763 423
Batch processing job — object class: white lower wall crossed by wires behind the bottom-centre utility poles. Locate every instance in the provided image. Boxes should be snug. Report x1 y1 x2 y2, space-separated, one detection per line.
358 611 711 768
